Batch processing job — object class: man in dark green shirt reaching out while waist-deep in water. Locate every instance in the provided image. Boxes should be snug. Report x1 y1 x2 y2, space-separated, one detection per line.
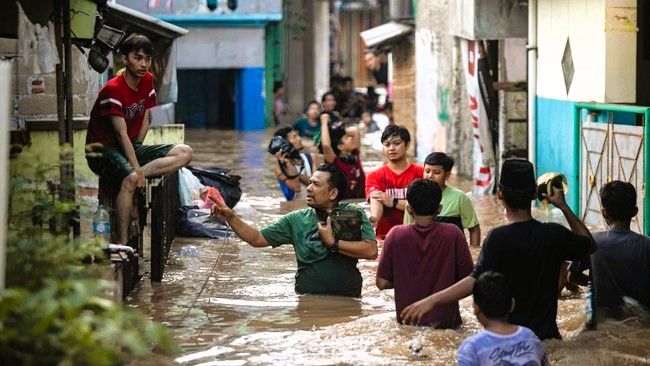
212 164 377 297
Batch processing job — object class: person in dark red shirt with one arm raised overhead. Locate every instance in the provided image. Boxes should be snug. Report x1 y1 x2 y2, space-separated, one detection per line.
320 113 366 199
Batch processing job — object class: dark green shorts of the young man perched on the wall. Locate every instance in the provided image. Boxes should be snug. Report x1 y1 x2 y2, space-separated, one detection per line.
86 141 176 183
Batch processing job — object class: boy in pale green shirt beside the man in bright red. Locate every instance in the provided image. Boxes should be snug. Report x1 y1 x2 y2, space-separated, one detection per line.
404 152 481 247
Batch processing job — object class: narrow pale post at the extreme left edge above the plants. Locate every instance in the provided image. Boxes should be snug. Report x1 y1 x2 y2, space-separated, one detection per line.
0 61 11 288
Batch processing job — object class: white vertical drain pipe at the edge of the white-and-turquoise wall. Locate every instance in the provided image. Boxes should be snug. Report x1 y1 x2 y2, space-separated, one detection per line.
526 0 537 167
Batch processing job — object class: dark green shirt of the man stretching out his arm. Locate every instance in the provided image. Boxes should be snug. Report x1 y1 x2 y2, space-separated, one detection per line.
260 203 377 297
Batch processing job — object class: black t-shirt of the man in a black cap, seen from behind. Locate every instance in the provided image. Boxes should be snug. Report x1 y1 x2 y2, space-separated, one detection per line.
472 219 590 339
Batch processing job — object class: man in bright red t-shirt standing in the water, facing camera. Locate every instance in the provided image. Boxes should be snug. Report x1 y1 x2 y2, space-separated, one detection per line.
366 125 424 239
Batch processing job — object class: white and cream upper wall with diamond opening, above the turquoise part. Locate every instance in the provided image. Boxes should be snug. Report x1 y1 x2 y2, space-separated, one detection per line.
537 0 636 103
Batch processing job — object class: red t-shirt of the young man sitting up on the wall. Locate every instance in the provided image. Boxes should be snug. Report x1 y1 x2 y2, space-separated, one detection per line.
86 72 156 146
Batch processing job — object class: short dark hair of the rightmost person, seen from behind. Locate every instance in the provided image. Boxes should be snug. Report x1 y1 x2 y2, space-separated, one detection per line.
600 180 636 222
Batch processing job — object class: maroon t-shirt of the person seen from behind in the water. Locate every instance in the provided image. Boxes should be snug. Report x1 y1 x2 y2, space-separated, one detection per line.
377 222 474 328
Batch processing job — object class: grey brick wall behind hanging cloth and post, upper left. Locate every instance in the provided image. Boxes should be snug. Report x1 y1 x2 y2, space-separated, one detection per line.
0 38 99 128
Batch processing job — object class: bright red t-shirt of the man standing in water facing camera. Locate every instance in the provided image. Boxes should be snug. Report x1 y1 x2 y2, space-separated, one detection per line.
366 163 424 239
